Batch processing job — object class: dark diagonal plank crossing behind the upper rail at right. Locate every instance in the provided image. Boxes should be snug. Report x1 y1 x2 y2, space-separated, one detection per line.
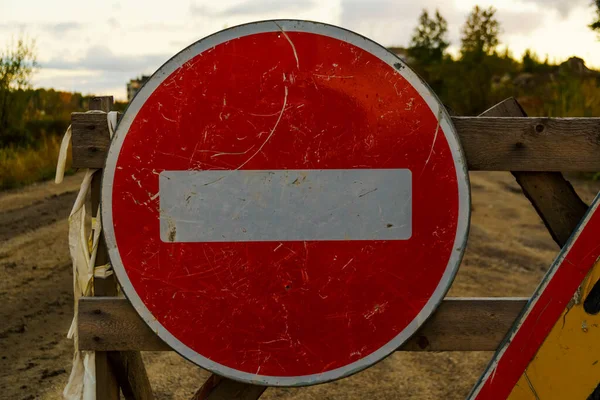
482 98 588 247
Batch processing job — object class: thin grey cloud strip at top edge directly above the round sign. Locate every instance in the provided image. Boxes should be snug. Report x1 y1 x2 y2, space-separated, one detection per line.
190 0 315 17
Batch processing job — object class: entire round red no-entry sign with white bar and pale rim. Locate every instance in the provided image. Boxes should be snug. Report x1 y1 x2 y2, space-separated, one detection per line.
102 21 469 385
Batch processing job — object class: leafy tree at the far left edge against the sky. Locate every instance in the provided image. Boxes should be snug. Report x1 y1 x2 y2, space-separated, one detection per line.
0 37 37 144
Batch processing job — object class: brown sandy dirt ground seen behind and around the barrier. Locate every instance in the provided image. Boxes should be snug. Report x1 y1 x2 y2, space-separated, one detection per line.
0 173 600 400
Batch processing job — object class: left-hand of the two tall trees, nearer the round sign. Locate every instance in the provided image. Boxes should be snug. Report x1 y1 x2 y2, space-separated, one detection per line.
408 8 450 65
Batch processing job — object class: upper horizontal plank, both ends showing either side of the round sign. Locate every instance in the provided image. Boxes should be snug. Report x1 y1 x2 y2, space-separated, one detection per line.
72 111 600 172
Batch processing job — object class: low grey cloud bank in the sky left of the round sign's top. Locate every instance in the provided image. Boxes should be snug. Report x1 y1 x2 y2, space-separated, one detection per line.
43 45 171 74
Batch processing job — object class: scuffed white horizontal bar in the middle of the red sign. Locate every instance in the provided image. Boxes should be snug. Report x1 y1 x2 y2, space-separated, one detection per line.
159 169 412 242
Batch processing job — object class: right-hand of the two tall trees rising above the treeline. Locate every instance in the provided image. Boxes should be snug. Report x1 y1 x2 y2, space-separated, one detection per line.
461 5 502 57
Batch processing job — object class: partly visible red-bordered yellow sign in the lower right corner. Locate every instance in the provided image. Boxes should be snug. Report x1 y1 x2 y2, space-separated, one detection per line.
469 196 600 400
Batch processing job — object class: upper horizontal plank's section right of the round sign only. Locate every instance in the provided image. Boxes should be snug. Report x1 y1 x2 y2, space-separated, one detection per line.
452 117 600 172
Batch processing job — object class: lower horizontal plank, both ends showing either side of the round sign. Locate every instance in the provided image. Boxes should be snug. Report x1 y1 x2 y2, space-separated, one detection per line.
78 297 527 351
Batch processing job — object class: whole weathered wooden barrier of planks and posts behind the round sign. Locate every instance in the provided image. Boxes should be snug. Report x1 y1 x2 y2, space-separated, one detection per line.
72 98 600 400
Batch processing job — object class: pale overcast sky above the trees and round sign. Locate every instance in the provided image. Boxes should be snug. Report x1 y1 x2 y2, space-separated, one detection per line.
0 0 600 99
